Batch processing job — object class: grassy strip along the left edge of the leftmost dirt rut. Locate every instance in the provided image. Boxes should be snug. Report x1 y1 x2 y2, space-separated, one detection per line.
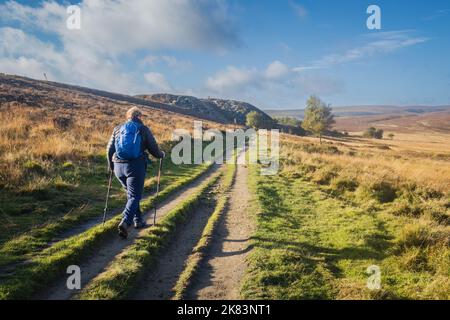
0 165 210 300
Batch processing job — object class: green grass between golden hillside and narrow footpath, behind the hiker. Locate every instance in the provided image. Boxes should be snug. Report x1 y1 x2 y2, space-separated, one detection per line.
0 155 206 267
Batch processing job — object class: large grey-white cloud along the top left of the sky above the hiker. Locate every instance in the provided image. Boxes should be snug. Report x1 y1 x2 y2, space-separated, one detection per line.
0 0 240 54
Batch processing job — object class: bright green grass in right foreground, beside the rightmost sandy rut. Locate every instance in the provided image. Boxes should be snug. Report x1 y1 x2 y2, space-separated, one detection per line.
241 167 450 299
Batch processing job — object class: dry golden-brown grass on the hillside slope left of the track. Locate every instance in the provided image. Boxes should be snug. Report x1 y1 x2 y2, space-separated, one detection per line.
0 85 224 188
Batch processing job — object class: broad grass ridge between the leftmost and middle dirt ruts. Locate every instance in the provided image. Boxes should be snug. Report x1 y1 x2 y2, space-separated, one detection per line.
77 168 222 300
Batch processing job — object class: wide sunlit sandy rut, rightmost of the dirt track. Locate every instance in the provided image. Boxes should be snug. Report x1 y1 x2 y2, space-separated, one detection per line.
186 153 254 300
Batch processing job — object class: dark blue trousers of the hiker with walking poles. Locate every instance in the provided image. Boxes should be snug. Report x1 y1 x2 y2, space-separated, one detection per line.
114 159 147 225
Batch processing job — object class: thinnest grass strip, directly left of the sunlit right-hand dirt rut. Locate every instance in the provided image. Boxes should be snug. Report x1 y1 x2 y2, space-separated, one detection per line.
173 161 236 300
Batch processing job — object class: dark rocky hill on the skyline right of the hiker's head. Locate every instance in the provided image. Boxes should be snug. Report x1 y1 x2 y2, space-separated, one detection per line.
136 94 272 125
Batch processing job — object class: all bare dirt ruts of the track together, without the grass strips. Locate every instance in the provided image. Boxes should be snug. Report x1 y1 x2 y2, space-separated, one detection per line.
35 154 254 300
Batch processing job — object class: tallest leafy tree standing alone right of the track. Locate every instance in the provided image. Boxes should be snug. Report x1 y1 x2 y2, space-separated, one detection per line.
302 96 335 143
